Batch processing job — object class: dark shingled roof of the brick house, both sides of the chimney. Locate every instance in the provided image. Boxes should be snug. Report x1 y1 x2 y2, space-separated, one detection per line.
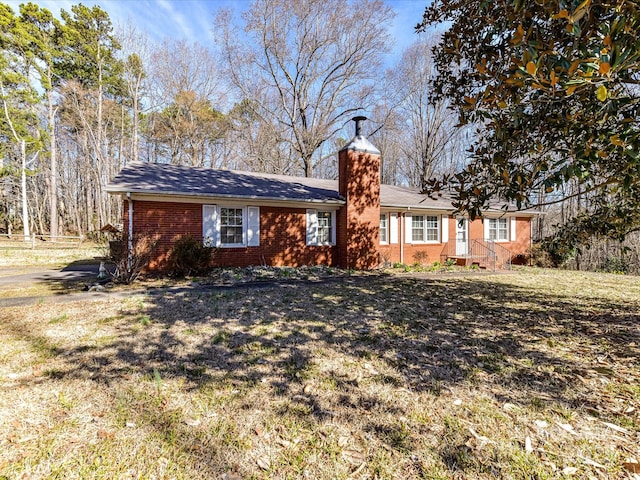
107 162 535 213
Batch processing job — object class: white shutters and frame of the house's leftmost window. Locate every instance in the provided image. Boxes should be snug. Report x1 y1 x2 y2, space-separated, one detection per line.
202 205 260 248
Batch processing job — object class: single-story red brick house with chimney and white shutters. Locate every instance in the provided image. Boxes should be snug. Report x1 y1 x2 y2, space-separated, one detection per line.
107 117 536 270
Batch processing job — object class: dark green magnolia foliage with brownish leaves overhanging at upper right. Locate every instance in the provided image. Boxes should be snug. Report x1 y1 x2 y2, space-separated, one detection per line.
417 0 640 246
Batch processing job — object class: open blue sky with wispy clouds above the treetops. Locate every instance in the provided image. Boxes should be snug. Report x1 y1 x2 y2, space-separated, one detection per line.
6 0 429 67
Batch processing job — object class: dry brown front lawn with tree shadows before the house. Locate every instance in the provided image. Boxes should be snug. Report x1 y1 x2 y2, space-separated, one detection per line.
0 270 640 479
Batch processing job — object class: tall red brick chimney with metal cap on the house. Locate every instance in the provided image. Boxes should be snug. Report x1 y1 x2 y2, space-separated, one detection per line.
337 116 380 270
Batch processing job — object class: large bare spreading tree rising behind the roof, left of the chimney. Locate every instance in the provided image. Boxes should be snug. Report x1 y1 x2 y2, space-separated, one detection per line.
216 0 393 176
